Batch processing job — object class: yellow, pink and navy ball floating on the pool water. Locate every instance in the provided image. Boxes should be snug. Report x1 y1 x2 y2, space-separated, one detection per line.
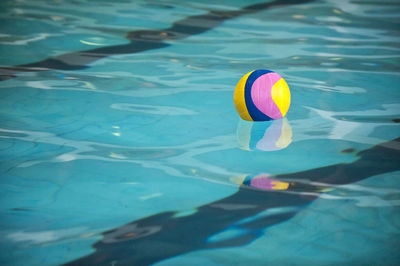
233 69 290 121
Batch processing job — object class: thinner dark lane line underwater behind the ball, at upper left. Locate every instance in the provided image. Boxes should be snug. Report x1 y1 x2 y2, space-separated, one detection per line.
0 0 313 81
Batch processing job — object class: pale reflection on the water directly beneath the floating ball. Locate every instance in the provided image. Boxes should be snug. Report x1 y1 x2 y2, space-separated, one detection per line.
237 118 293 151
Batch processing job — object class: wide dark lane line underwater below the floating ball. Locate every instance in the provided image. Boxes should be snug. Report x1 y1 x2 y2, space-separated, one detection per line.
66 138 400 265
